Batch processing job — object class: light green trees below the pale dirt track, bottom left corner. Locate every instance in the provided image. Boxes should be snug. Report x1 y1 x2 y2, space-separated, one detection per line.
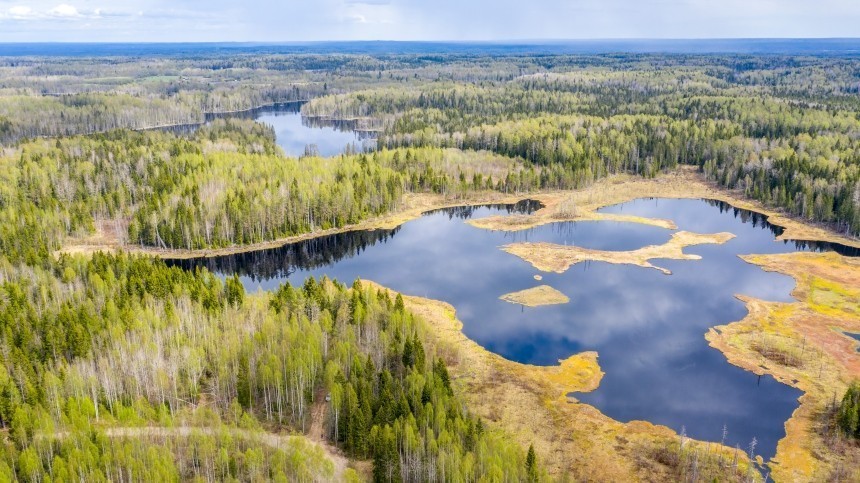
0 427 334 482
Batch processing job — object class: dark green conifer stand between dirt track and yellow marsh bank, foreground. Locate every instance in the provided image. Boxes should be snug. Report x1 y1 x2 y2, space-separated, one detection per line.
270 279 537 481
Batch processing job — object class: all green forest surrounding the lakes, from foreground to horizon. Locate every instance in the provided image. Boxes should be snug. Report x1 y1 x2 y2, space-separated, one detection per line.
0 49 860 482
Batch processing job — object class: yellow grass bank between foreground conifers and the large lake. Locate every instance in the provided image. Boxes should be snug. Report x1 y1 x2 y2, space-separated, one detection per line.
368 282 764 482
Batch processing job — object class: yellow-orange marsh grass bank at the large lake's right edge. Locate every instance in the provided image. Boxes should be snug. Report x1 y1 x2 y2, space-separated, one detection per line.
706 253 860 482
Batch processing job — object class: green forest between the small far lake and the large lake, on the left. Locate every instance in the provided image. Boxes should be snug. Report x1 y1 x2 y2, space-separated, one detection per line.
0 120 539 263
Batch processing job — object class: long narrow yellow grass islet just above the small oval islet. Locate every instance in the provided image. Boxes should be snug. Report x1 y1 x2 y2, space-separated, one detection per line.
502 231 734 275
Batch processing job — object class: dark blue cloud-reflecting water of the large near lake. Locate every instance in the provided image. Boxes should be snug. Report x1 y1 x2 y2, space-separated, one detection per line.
168 200 860 459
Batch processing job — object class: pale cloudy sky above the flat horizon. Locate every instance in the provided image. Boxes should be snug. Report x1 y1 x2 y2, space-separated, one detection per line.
0 0 860 42
